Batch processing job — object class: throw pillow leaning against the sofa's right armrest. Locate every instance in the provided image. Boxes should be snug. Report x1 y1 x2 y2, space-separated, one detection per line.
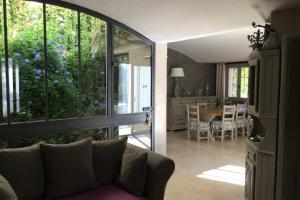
117 148 148 196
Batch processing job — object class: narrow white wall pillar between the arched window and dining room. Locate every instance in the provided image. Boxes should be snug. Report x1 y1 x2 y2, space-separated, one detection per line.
154 43 168 155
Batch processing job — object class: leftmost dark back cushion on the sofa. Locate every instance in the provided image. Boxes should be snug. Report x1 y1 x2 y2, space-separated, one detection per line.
0 144 45 200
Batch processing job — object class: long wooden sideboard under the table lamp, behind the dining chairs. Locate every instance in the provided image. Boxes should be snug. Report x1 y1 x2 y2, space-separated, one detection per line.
167 96 216 130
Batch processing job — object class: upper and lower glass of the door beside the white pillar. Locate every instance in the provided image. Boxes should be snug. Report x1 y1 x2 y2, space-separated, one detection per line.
112 26 152 149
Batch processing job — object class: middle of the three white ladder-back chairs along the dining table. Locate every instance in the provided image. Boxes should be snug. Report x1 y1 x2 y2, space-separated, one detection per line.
212 105 235 142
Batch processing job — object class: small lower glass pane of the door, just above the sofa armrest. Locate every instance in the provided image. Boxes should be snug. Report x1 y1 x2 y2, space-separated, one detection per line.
114 124 151 149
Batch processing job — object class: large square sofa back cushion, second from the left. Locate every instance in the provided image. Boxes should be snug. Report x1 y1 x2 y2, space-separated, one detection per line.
41 140 97 197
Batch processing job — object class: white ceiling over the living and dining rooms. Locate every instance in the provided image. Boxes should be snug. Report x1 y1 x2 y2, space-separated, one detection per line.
65 0 300 62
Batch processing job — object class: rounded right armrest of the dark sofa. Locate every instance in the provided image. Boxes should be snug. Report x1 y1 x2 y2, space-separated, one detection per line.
127 144 175 200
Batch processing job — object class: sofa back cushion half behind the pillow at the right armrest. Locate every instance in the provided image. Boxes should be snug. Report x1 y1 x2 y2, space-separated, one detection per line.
92 138 127 185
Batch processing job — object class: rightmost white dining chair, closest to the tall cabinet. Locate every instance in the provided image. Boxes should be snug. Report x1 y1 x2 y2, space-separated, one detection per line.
235 104 248 137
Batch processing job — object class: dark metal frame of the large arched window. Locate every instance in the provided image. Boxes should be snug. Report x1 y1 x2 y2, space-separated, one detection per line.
0 0 155 150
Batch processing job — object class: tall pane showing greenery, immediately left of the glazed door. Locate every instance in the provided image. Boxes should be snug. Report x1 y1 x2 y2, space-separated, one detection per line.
80 14 106 116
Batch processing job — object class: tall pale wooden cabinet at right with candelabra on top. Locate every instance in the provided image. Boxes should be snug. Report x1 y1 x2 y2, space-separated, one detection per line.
245 49 280 200
